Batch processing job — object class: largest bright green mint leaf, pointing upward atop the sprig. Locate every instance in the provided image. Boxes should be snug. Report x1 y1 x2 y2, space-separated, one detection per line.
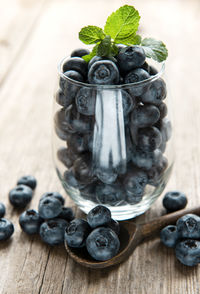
104 5 140 44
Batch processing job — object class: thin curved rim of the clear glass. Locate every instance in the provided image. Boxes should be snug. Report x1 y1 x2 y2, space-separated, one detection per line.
57 56 165 89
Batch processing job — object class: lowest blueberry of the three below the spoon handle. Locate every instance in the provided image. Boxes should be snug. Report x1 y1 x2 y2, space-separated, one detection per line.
175 239 200 266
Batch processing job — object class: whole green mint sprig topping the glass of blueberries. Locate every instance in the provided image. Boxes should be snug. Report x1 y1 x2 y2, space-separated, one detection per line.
79 5 168 62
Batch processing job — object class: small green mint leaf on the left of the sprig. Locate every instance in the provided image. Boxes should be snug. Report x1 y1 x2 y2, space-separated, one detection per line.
79 26 105 45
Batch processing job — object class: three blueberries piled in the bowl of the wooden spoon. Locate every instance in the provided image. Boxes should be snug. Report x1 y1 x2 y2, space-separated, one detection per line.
65 205 120 261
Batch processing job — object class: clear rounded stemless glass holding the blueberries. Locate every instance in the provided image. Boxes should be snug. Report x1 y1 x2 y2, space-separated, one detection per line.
53 58 174 220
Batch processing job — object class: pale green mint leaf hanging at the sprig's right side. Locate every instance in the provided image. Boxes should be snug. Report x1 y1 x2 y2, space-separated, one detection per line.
141 38 168 62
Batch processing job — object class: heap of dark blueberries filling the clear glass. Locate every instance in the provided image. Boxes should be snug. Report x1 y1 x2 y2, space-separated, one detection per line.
54 45 171 206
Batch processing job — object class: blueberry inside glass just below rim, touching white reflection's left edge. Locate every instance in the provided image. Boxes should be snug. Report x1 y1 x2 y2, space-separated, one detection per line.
76 87 96 115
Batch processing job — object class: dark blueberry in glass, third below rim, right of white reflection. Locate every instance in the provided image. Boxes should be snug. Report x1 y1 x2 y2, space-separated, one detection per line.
137 127 162 152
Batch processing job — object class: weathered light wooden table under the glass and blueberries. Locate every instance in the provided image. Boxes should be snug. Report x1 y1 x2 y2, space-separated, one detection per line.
0 0 200 294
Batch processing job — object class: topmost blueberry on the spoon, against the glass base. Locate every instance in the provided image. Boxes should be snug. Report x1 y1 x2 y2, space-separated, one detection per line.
87 205 111 228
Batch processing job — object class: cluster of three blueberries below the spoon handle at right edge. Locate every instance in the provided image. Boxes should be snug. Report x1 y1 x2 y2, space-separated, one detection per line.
160 214 200 266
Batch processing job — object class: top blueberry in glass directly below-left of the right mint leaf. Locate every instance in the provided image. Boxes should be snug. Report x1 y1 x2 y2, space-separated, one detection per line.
117 46 146 73
